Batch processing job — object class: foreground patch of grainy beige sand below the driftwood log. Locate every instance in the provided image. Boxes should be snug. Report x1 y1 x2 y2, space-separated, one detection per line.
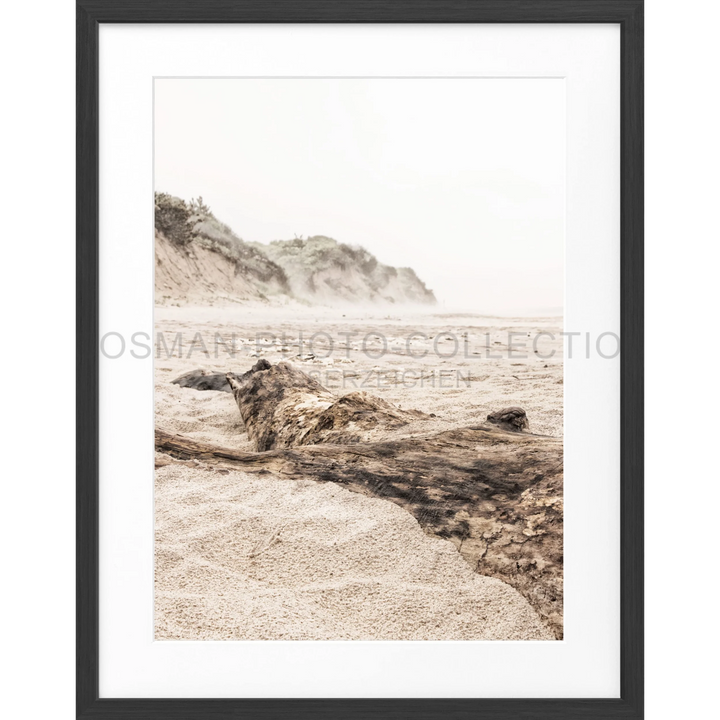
155 465 553 640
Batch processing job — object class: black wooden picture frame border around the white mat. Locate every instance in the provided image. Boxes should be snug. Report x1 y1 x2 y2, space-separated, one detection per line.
73 0 647 720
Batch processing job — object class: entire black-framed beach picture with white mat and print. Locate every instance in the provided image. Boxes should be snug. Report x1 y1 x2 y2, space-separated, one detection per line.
73 0 646 718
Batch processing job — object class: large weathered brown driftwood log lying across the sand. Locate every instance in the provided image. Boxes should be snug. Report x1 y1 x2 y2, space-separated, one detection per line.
160 361 563 638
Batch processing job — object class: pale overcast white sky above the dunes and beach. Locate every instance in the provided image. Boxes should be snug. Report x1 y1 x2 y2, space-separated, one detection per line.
155 78 565 314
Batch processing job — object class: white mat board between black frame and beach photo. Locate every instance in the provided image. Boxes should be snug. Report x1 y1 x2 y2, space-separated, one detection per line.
100 25 620 698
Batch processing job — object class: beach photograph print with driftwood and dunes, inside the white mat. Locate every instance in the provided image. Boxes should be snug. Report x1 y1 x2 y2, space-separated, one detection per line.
153 77 566 641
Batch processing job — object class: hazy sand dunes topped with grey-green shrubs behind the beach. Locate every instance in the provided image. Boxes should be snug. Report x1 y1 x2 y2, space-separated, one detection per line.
155 193 436 306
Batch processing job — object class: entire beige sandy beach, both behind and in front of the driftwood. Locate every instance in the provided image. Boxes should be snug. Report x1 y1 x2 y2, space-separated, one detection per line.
155 303 563 640
